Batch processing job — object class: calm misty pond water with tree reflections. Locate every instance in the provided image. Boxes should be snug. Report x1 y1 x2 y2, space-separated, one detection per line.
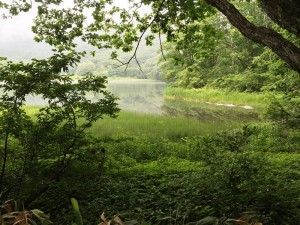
1 79 257 122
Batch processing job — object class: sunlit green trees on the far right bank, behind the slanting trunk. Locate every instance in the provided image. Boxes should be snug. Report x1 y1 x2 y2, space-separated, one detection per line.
160 2 298 92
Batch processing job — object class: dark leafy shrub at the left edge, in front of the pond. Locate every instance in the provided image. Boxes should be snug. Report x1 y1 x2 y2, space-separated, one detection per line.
0 28 119 204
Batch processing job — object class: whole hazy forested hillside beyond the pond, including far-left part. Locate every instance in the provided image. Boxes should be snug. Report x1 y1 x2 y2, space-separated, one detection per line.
0 35 162 80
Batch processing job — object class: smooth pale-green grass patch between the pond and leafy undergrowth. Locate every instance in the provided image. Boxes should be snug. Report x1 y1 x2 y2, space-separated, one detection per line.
91 111 240 140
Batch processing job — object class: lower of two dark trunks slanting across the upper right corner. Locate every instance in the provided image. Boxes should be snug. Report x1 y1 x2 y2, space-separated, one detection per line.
206 0 300 73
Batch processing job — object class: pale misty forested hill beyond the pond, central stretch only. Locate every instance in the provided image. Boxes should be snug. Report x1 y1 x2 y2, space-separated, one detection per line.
70 40 162 80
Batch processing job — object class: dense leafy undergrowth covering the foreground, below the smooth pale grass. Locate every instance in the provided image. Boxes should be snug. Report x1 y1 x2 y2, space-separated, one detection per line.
23 116 300 225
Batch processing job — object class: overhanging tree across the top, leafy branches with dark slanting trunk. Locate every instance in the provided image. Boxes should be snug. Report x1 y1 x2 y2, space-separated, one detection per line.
0 0 300 72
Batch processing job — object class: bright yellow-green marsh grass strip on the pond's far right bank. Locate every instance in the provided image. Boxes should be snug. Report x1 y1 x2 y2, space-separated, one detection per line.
164 88 267 109
